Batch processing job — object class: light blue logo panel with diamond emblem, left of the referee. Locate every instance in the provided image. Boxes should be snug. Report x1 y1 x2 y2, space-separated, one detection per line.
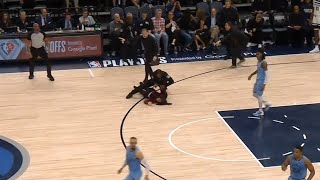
0 39 24 60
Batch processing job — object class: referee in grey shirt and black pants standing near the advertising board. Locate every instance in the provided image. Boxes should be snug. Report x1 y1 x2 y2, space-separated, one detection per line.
27 23 54 81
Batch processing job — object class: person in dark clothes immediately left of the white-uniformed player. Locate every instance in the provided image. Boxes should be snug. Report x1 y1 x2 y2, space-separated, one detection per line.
301 0 314 46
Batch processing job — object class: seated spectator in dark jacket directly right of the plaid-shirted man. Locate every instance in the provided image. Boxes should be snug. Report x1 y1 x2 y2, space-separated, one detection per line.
166 12 182 53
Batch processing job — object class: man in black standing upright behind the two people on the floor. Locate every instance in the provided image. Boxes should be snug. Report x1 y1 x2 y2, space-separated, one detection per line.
141 27 158 82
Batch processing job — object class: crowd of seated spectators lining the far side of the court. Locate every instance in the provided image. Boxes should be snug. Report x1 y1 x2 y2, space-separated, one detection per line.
0 0 313 57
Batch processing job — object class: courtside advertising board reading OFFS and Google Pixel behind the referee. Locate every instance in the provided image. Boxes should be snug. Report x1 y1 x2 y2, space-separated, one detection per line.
0 34 103 60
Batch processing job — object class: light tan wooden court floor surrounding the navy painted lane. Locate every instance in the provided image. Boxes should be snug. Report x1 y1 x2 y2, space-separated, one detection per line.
0 54 320 180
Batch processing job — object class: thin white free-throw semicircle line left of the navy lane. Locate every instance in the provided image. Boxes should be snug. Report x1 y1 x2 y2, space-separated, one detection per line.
168 118 270 162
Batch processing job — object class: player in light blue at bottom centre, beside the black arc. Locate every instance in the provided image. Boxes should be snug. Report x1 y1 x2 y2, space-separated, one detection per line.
118 137 150 180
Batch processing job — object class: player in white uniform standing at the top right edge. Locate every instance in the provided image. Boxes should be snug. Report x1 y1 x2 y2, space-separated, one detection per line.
310 0 320 53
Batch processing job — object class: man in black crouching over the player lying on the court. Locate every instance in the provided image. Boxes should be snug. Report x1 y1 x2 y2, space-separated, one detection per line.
126 69 174 99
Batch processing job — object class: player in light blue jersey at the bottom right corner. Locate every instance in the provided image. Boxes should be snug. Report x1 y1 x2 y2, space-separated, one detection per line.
281 146 315 180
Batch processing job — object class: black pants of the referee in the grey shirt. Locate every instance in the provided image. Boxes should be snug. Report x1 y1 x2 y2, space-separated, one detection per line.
29 47 51 76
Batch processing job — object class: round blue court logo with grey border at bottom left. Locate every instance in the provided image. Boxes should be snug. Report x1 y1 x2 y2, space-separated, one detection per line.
0 136 30 180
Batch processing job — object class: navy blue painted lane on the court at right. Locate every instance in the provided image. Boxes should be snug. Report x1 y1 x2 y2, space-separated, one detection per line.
219 104 320 167
